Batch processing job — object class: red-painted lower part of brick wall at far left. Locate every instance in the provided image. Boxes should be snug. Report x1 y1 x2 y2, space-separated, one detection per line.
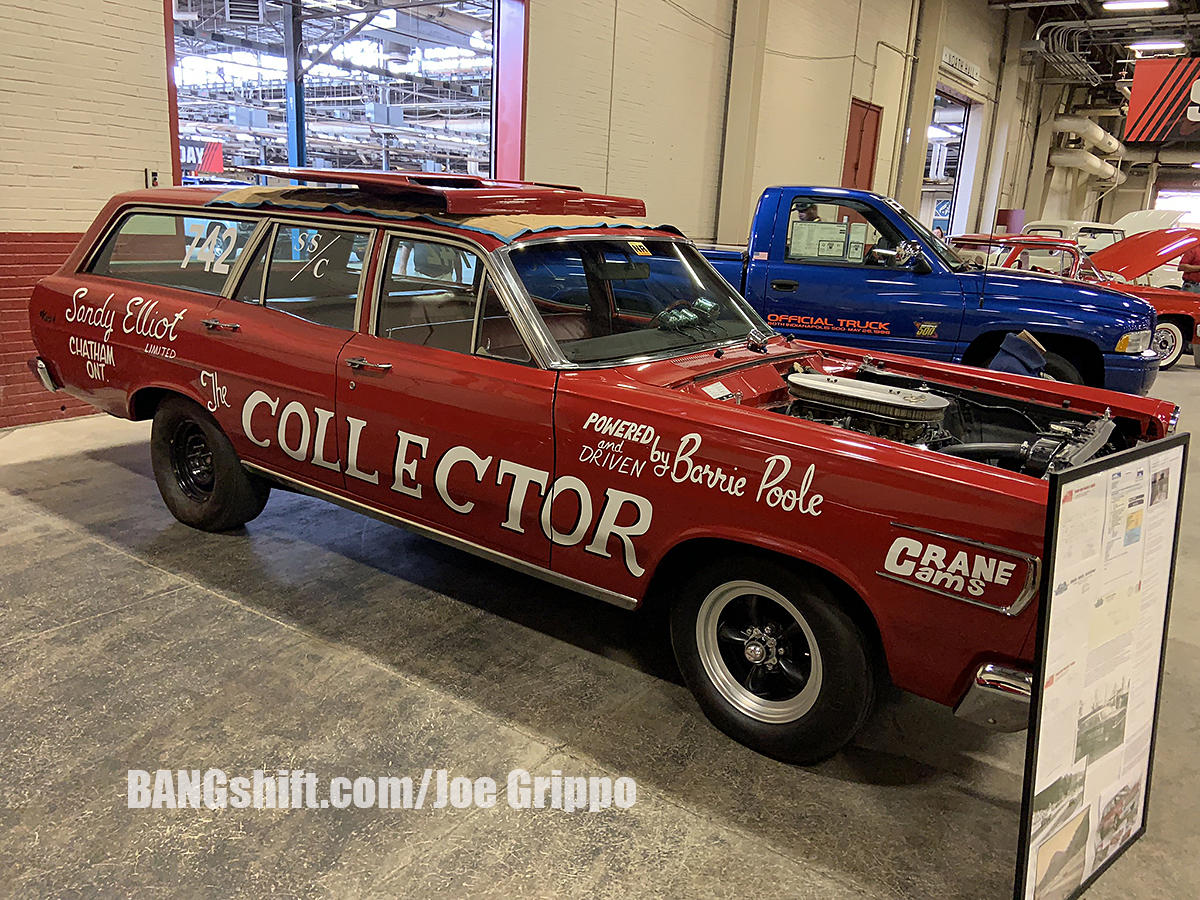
0 232 95 428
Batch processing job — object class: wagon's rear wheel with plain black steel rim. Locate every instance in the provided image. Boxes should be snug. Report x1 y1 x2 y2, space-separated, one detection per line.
150 396 271 532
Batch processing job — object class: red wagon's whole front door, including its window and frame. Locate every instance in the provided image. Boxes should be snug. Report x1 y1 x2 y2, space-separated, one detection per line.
328 234 556 568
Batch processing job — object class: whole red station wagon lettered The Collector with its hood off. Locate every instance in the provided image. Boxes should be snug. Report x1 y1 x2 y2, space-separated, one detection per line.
30 170 1178 762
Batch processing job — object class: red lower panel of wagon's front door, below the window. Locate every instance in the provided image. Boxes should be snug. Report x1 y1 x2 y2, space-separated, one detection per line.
337 334 554 568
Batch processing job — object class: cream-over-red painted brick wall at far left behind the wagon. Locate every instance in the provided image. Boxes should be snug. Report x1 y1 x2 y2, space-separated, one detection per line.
0 0 173 427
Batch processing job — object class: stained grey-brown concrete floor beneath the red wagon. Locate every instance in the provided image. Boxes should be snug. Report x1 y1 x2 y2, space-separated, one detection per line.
0 365 1200 900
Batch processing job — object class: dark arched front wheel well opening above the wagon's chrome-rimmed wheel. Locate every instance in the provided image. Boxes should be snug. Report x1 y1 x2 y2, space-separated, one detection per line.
642 538 890 680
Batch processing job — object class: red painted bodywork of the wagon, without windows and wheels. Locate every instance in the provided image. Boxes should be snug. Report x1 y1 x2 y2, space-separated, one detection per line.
30 188 1176 720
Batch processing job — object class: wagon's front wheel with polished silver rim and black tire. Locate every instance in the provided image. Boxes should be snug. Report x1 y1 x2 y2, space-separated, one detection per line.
671 557 875 764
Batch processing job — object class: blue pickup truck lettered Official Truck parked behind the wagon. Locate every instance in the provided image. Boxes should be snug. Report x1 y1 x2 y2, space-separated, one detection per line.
701 187 1158 394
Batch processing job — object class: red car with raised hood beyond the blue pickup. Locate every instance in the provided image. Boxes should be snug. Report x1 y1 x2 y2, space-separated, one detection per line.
948 228 1200 368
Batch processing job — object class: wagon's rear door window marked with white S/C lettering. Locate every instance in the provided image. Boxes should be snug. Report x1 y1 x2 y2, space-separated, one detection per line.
236 224 371 331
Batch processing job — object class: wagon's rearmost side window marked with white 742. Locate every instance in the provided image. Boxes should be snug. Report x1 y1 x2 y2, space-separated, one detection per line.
88 212 257 294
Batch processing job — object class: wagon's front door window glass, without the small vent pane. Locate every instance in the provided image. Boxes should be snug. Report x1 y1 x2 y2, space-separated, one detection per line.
376 235 484 354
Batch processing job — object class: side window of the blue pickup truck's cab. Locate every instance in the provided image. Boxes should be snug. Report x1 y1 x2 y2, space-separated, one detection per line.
785 194 904 266
